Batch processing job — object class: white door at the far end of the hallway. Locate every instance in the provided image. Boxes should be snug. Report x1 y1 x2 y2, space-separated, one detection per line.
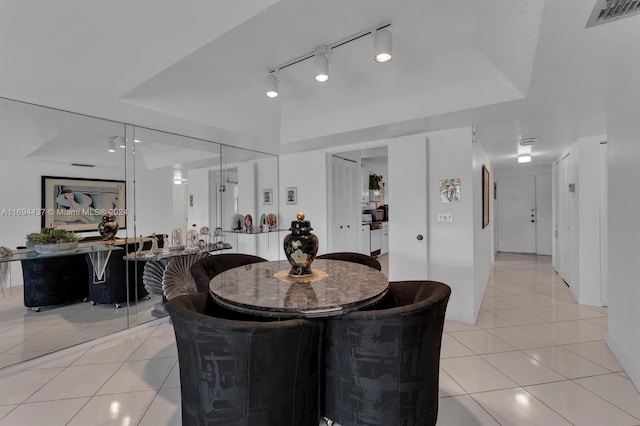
496 176 536 253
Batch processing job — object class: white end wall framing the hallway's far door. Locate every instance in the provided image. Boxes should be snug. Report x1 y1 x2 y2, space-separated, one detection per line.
491 165 553 256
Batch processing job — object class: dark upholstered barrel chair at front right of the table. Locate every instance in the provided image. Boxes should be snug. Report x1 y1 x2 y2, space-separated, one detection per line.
323 281 451 426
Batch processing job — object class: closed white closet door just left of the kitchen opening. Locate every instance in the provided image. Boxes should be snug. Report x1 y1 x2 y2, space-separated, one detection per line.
329 155 362 252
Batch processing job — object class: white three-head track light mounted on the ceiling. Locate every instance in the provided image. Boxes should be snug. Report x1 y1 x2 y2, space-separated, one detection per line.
265 22 392 98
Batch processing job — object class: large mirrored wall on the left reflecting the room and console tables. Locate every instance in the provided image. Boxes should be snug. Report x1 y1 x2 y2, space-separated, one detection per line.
0 99 284 368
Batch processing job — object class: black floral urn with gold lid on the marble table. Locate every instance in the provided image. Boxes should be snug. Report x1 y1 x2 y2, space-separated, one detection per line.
284 212 318 277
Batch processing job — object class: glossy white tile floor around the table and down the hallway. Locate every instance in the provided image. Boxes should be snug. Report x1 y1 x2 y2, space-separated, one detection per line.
0 253 640 426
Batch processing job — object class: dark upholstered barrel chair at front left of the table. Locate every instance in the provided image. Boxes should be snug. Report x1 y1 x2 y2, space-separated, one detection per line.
166 292 323 426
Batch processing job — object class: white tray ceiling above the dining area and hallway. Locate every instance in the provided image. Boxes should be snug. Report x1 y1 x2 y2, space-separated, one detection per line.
0 0 640 167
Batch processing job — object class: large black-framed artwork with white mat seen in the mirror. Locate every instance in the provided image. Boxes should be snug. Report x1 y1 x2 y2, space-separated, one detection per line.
41 176 128 232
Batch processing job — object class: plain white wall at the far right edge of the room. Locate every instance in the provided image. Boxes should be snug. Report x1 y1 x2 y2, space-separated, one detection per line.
606 88 640 389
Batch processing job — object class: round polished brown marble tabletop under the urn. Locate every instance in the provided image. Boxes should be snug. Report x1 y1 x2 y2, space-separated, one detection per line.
209 259 389 318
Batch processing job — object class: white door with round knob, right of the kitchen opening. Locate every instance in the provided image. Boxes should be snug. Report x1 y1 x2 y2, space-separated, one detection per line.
388 135 429 281
